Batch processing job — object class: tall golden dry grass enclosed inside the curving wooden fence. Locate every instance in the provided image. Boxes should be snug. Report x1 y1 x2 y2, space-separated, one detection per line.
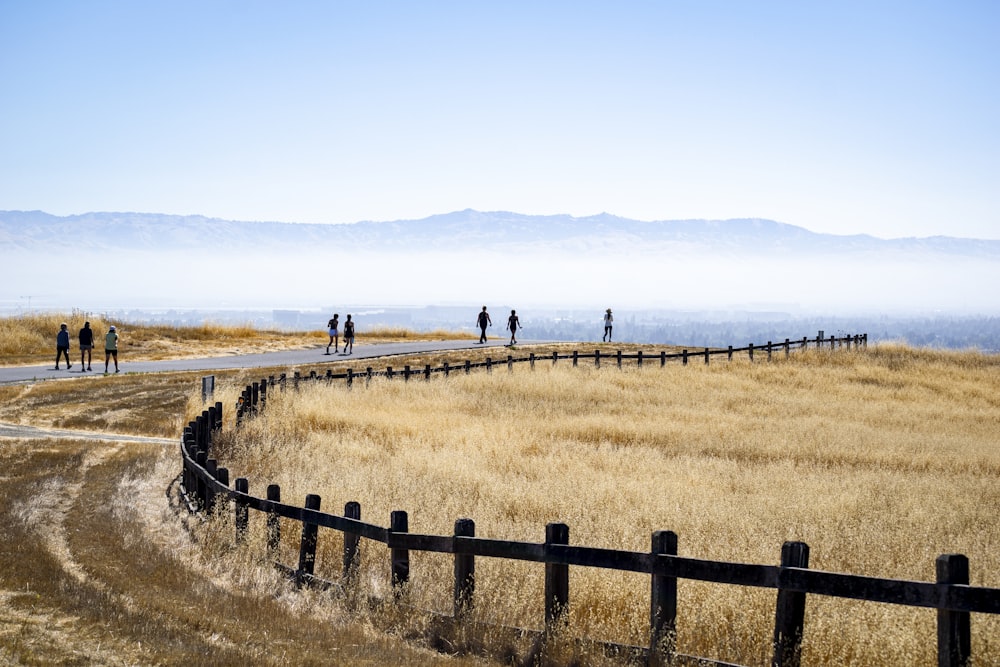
189 345 1000 665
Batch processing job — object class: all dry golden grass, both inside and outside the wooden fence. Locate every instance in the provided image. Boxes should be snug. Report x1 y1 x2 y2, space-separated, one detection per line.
0 318 1000 665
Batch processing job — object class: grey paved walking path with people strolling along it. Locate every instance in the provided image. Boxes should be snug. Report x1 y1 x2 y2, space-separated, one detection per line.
0 339 546 384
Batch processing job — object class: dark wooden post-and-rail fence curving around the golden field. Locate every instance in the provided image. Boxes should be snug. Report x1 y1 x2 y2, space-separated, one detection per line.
181 336 1000 667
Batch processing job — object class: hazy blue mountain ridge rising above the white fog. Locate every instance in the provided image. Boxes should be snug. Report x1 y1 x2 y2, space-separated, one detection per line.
0 209 1000 258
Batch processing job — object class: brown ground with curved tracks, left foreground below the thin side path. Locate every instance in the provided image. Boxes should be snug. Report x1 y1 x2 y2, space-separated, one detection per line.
0 435 480 665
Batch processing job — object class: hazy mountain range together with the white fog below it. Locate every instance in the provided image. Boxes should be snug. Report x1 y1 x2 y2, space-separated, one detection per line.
0 210 1000 314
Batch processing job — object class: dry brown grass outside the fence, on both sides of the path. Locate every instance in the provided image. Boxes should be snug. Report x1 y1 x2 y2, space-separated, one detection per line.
0 316 481 666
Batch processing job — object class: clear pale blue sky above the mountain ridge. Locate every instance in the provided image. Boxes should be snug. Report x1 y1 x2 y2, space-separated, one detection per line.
0 0 1000 239
